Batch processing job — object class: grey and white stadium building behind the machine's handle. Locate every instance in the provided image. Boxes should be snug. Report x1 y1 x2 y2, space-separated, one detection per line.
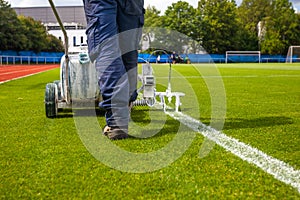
13 6 87 47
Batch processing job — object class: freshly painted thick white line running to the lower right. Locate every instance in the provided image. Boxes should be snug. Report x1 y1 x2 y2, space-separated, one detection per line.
166 111 300 193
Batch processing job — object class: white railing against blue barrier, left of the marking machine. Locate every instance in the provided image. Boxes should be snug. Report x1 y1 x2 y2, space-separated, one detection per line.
0 55 61 65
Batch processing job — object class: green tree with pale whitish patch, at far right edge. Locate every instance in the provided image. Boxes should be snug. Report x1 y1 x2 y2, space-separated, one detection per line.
238 0 300 54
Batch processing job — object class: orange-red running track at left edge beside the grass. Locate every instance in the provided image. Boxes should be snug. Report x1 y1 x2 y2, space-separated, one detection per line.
0 65 59 83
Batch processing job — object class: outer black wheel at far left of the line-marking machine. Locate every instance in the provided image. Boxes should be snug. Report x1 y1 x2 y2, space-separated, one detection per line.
45 83 58 118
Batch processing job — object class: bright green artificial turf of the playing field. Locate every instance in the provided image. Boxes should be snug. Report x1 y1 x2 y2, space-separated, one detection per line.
0 64 300 199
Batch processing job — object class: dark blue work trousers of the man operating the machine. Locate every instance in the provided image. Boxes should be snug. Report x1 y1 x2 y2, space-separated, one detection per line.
83 0 144 127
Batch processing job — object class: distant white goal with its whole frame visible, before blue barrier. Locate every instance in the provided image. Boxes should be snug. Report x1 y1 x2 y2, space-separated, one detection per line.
225 51 261 63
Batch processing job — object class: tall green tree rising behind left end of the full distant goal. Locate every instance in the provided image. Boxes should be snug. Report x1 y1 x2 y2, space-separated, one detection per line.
198 0 238 53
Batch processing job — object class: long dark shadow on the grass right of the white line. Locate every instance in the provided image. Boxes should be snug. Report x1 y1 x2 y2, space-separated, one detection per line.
223 116 293 130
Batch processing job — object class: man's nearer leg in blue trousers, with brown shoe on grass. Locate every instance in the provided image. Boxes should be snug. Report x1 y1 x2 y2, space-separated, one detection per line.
84 0 129 139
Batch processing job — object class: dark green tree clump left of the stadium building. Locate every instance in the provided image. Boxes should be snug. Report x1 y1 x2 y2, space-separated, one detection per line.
0 0 63 52
